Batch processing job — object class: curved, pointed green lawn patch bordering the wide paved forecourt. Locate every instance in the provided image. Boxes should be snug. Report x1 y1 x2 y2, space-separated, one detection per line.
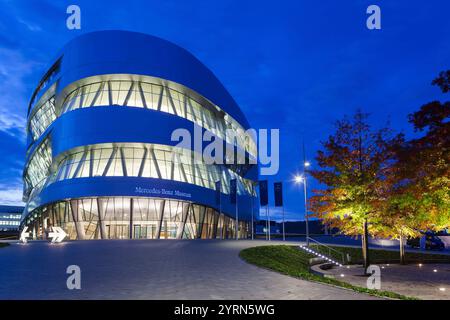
239 245 414 300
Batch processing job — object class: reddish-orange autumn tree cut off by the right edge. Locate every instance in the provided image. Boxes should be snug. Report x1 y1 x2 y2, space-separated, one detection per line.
378 70 450 263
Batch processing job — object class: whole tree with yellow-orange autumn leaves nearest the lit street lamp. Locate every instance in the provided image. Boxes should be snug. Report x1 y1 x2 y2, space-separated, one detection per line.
309 111 401 269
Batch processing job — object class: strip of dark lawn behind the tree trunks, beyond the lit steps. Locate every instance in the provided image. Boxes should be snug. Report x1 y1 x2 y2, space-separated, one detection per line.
311 245 450 264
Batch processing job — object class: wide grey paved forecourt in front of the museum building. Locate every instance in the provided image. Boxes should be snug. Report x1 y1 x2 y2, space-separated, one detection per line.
0 240 380 300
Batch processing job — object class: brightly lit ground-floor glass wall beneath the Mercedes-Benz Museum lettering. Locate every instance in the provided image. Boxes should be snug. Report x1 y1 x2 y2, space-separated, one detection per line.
27 197 250 240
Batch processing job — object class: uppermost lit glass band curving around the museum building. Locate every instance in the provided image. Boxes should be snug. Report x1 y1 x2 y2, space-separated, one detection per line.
30 80 256 156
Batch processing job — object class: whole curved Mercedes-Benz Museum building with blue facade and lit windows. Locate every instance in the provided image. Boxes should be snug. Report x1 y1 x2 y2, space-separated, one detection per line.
22 31 258 239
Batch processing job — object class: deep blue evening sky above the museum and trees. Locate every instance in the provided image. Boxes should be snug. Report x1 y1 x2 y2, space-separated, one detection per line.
0 0 450 219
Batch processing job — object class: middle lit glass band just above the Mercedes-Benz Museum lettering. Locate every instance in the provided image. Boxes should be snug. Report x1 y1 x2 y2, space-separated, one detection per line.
48 144 252 194
